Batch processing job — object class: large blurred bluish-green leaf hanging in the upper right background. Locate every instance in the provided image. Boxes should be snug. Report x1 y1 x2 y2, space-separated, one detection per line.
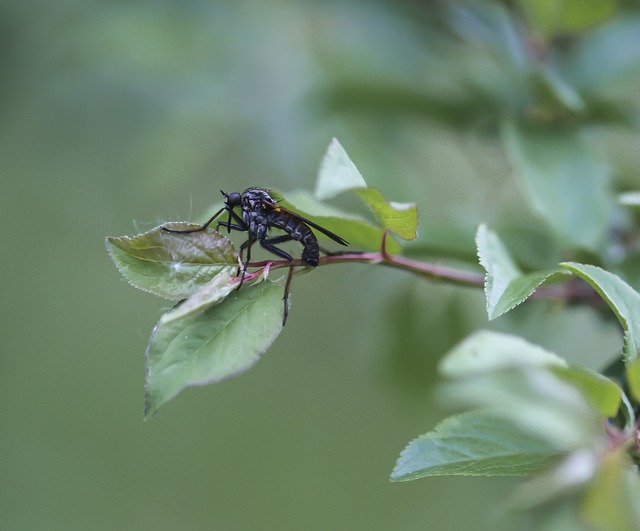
502 120 613 251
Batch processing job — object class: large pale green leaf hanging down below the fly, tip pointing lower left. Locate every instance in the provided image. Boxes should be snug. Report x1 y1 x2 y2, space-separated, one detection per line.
145 282 283 417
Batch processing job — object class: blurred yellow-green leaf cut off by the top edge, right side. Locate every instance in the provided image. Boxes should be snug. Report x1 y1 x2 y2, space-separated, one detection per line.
521 0 615 38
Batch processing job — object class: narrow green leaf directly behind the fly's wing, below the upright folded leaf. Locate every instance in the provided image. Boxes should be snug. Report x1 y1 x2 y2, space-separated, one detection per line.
282 191 400 254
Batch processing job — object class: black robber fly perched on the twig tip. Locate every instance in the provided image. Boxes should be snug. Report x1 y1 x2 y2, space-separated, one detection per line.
163 188 349 325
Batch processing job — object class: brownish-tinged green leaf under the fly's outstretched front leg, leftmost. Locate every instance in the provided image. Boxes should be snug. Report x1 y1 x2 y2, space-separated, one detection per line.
107 223 238 300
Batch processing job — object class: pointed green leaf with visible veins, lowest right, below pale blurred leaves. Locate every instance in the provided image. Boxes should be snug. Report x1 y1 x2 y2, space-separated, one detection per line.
391 410 557 481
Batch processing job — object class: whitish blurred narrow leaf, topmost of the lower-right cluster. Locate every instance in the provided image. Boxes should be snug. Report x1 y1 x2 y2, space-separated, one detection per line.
438 330 567 378
